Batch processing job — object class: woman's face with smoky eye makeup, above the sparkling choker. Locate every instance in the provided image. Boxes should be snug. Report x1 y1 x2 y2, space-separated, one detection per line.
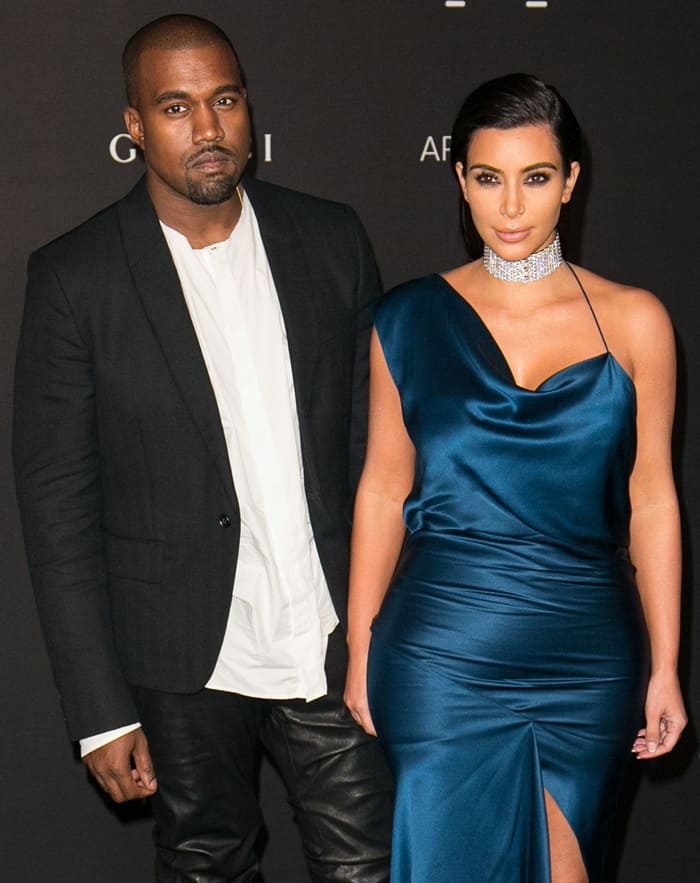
455 125 579 261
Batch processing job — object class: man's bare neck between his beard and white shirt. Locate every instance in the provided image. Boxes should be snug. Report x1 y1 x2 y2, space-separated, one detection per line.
147 180 243 248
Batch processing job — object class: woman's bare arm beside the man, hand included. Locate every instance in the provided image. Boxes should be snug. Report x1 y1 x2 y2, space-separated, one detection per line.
345 331 415 735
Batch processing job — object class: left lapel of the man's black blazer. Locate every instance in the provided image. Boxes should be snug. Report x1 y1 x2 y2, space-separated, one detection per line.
113 178 237 506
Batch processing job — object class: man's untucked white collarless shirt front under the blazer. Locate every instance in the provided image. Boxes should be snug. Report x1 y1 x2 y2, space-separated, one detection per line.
161 193 338 700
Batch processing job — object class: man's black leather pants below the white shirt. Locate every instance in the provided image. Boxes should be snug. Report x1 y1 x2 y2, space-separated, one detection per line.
133 640 393 883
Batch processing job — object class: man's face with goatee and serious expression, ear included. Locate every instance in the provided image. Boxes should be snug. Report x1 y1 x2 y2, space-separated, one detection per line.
124 43 251 205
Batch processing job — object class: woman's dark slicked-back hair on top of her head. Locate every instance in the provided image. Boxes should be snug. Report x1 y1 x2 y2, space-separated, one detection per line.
451 74 581 175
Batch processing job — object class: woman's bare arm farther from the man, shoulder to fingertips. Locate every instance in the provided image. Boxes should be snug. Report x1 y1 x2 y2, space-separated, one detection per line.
628 292 687 760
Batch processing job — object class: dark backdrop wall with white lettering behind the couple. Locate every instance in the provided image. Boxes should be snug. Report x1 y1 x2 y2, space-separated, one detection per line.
0 0 700 883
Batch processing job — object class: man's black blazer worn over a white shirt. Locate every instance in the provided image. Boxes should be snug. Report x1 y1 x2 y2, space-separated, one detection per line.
13 179 378 738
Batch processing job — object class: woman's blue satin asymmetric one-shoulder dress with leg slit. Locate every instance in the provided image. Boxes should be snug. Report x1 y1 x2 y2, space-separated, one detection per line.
369 275 648 883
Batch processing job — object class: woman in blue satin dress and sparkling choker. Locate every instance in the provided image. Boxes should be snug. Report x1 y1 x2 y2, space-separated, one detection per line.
346 74 686 883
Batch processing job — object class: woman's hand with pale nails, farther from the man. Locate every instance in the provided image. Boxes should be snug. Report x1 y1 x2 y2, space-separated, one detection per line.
632 672 688 760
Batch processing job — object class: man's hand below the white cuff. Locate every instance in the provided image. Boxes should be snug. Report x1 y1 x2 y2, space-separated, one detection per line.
83 727 158 803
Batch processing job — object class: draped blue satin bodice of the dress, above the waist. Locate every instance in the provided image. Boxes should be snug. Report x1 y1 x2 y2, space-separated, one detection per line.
375 274 636 567
